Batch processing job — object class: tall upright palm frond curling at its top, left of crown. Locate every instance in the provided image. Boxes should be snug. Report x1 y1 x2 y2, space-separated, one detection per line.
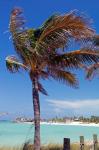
10 8 41 67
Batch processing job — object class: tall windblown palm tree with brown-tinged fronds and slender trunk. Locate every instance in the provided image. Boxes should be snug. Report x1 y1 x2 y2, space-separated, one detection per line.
6 8 99 150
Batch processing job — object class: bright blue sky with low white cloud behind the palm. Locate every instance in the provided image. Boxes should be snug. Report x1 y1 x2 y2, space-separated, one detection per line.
0 0 99 119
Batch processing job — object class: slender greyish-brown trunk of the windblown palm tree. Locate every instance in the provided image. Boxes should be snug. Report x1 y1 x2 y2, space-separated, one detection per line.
32 78 40 150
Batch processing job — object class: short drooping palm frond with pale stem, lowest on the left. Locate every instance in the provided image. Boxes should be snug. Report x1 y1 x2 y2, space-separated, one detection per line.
6 56 29 73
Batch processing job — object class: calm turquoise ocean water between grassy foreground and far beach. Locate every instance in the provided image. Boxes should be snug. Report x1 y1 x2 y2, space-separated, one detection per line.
0 121 99 146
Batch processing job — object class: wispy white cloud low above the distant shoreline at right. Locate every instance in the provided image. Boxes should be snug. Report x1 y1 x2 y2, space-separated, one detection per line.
47 99 99 115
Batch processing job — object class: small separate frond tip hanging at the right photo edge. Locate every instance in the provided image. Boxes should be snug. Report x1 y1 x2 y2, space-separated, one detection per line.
86 63 99 79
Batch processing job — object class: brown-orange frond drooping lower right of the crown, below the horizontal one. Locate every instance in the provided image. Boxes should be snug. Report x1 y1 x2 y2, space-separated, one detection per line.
49 68 78 88
